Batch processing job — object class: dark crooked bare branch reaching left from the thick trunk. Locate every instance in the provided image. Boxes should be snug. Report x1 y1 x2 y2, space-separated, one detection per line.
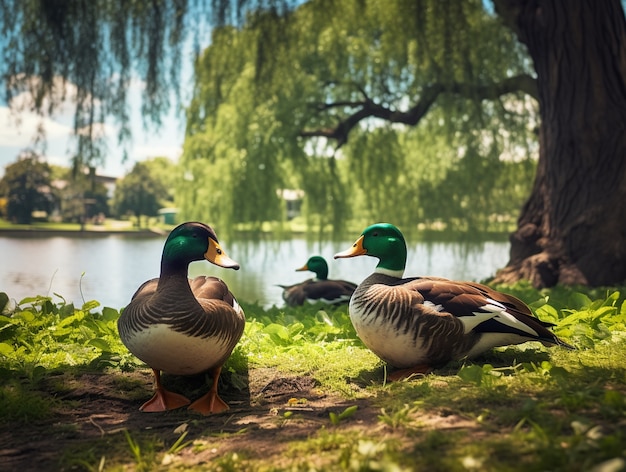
299 74 538 149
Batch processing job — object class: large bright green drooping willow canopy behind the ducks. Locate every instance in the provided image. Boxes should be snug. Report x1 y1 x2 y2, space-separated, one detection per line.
182 0 537 233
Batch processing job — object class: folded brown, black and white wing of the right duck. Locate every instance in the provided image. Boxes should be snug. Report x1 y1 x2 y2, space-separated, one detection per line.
404 277 572 348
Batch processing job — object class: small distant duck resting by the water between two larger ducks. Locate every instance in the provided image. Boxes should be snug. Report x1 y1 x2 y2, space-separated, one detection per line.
280 256 356 306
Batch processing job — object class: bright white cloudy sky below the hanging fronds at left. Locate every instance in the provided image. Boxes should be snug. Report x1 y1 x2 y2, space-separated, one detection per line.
0 80 192 177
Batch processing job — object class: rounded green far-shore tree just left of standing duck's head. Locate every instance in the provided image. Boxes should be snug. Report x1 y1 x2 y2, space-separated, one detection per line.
113 162 168 228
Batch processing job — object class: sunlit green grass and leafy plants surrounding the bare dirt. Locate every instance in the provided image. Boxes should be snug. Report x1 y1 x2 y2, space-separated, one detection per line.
0 284 626 471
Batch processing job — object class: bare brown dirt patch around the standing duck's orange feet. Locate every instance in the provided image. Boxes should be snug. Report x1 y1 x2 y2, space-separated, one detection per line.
0 369 394 472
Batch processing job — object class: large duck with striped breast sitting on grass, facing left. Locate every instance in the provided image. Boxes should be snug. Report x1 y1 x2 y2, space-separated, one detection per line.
335 223 573 380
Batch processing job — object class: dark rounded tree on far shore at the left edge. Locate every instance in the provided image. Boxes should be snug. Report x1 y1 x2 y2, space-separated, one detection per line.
0 151 55 224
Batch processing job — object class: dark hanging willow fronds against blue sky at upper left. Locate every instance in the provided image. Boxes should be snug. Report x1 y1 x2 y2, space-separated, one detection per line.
0 0 290 165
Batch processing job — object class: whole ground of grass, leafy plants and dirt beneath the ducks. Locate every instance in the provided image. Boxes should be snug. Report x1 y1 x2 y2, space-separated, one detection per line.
0 284 626 471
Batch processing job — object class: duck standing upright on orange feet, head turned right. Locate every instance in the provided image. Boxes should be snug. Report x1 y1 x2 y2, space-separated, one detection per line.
118 222 245 414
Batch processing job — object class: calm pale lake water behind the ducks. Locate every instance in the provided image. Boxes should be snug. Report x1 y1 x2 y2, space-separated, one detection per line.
0 235 509 309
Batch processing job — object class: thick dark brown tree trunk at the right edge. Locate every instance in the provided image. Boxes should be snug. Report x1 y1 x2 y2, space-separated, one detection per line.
495 0 626 287
